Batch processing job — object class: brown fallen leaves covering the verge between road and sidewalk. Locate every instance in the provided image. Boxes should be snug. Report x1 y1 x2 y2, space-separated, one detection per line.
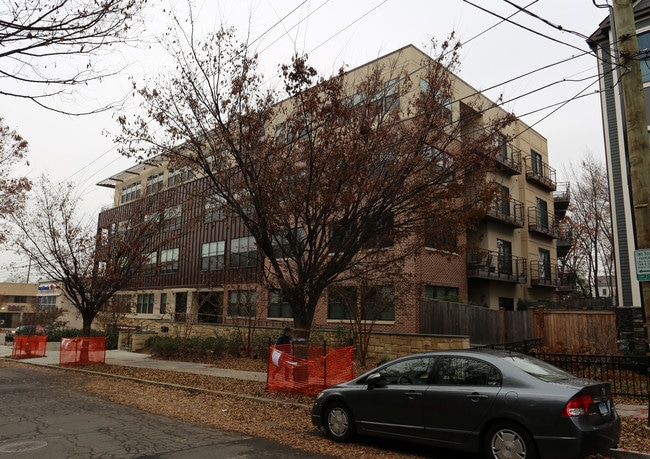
2 358 650 459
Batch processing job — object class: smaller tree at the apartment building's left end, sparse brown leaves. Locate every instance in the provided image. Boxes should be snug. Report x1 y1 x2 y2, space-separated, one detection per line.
11 177 178 336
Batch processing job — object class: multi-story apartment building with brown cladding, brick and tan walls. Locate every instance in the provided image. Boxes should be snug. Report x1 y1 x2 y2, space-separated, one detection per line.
98 46 568 333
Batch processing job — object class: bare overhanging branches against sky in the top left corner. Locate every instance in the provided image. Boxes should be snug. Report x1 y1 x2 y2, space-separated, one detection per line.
0 0 146 111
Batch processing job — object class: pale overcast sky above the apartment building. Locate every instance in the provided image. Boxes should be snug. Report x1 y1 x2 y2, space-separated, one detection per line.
0 0 609 282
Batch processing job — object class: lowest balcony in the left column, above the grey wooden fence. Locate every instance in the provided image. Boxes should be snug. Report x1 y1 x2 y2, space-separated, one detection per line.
467 250 527 284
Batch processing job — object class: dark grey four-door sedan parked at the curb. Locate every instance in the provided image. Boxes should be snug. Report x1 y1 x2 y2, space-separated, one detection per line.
311 350 621 459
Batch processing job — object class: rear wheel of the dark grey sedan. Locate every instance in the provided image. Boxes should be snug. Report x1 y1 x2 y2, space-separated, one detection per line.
484 423 537 459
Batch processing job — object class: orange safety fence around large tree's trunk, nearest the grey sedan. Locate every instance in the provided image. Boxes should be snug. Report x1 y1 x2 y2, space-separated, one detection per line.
266 344 354 395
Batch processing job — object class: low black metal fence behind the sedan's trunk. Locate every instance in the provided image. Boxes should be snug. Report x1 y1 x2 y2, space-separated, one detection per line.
530 352 650 398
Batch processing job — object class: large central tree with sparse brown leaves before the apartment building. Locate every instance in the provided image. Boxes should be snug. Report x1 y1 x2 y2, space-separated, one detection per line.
119 24 511 348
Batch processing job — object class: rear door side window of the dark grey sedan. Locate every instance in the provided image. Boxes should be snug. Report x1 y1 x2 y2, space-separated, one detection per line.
435 357 502 386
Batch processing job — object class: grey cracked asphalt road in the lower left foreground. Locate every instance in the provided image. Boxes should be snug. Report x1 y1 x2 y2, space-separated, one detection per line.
0 365 323 459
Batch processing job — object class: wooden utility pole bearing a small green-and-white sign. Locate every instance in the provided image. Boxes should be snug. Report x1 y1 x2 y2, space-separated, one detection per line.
612 0 650 352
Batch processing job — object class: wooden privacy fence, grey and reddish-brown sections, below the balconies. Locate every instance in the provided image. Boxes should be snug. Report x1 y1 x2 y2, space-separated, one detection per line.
420 300 618 354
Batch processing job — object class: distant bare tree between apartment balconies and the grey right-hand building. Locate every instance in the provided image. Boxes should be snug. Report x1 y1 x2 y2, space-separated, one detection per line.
566 153 615 298
